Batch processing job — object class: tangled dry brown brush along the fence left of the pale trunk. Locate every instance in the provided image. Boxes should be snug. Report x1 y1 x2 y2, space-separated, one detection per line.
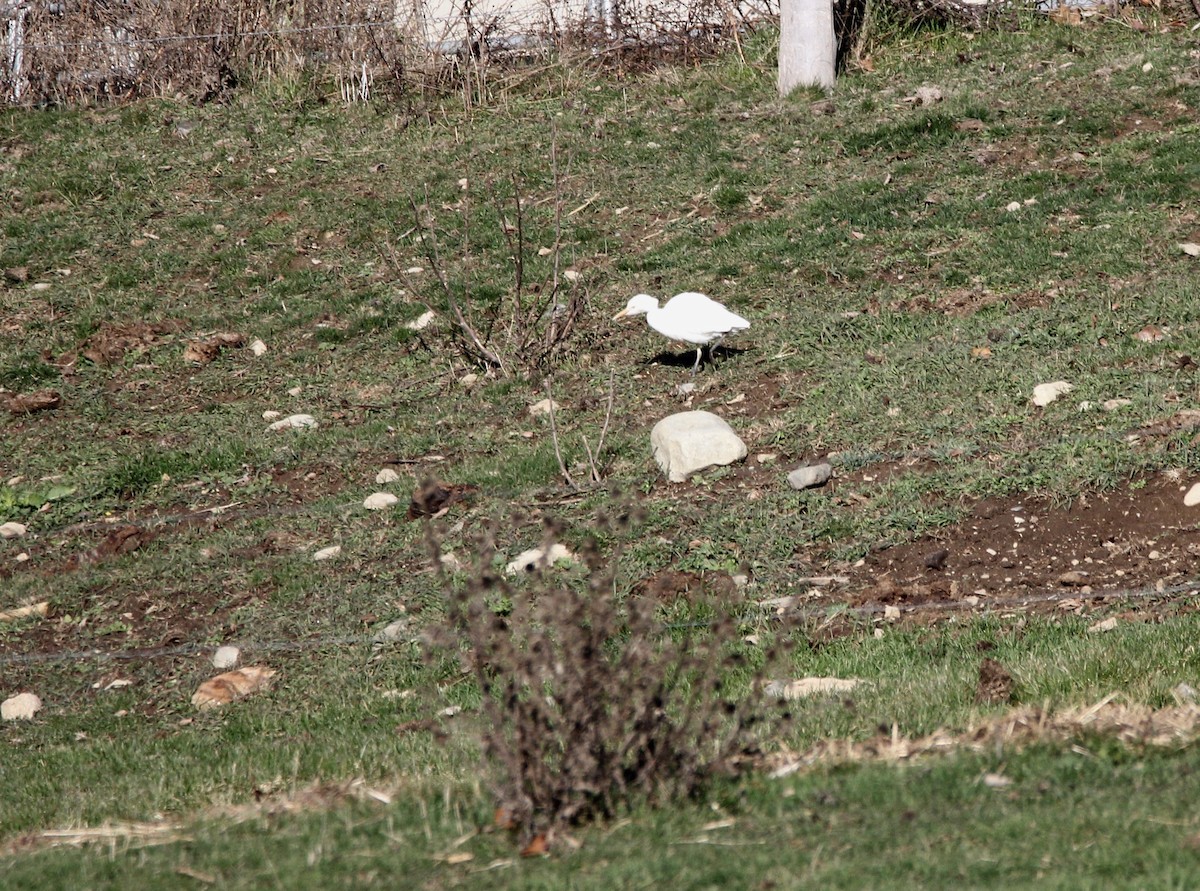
0 0 778 104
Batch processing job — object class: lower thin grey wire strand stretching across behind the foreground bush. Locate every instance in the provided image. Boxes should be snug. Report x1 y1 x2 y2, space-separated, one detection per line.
0 580 1200 665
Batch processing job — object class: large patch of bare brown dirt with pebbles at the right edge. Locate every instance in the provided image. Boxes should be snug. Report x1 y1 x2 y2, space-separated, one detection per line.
847 473 1200 609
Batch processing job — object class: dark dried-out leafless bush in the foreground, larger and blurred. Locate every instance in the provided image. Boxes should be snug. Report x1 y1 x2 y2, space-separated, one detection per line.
430 508 782 833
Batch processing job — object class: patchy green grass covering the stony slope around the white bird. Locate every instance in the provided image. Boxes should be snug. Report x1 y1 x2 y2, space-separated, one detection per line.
0 12 1200 889
